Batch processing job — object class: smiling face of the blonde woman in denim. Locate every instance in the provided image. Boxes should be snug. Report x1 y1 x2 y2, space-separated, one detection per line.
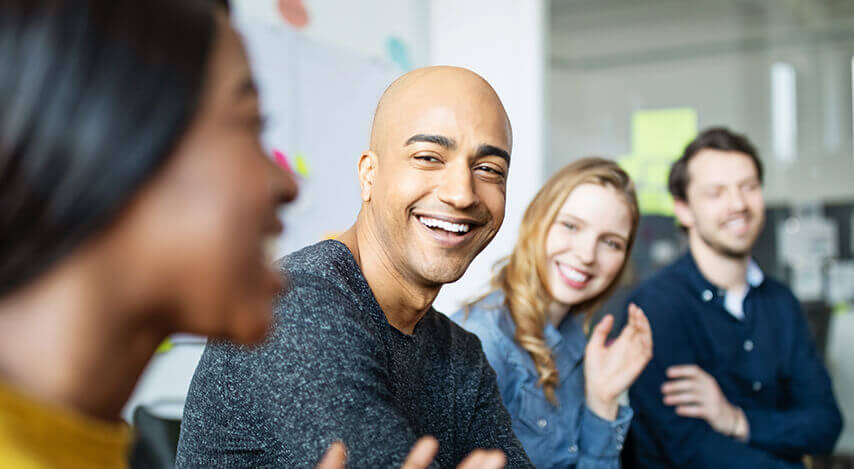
545 183 632 307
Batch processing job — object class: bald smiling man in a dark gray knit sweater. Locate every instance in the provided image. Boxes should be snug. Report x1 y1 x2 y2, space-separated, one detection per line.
178 67 531 468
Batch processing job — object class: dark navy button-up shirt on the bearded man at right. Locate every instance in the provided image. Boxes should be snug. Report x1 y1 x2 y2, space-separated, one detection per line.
629 252 842 469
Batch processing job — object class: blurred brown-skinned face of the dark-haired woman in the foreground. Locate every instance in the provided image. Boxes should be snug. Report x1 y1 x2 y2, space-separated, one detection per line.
127 15 297 343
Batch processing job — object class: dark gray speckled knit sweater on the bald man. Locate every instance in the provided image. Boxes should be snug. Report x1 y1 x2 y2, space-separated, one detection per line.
177 241 532 468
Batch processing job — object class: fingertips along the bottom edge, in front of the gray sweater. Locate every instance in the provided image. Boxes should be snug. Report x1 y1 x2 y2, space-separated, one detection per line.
316 436 505 469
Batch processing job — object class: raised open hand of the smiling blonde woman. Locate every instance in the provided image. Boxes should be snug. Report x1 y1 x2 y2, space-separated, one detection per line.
584 304 652 420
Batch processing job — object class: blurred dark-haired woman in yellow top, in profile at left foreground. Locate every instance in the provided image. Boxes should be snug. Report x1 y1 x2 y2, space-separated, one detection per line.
0 0 296 468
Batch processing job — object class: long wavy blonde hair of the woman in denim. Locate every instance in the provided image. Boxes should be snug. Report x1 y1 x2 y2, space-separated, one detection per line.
467 157 640 405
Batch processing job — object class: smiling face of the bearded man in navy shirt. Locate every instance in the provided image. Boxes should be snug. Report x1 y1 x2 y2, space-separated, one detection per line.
676 149 765 258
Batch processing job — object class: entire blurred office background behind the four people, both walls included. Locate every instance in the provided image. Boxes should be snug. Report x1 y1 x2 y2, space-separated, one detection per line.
125 0 854 464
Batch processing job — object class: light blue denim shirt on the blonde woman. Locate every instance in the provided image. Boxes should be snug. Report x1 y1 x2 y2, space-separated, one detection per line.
451 291 632 468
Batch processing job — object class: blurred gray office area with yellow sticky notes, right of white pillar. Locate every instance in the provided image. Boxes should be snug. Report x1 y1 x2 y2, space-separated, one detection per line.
543 0 854 453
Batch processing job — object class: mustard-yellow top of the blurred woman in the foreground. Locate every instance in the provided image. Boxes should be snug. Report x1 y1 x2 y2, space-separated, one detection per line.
0 381 131 469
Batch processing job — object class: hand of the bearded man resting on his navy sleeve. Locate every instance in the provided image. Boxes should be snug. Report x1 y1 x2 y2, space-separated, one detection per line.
661 365 749 440
